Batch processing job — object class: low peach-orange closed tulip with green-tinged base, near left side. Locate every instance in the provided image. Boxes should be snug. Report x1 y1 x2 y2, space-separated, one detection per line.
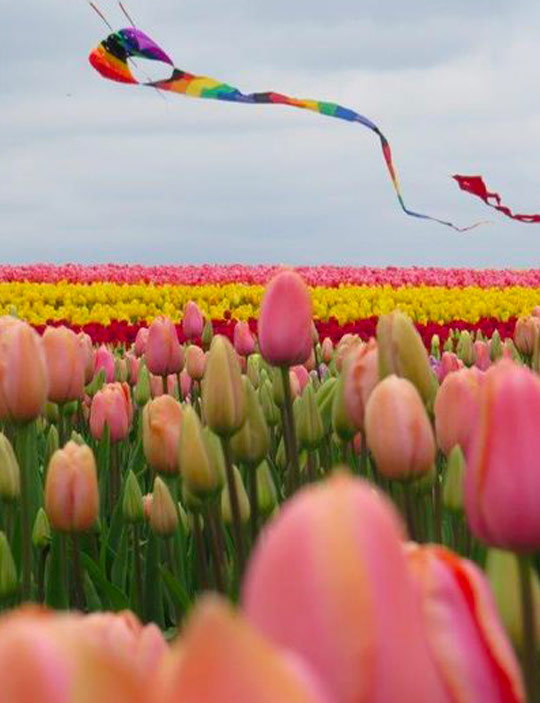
45 442 99 532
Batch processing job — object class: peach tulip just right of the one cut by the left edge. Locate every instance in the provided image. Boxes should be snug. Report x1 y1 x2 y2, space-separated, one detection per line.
42 327 86 403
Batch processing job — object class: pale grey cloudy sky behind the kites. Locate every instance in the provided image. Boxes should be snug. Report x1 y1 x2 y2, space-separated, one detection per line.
0 0 540 268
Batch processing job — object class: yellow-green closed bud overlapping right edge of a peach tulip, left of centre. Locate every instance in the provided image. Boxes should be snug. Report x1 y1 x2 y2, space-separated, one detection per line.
178 405 223 498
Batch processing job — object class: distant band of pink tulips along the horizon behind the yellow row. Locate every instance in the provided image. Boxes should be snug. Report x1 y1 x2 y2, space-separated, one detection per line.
0 264 540 288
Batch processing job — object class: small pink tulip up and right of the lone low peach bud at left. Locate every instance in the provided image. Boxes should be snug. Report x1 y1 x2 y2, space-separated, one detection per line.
90 383 132 442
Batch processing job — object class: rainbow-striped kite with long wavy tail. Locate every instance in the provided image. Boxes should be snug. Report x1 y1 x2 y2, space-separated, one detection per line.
89 27 485 232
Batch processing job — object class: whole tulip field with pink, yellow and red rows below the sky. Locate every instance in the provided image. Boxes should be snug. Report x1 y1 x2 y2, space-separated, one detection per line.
0 265 540 703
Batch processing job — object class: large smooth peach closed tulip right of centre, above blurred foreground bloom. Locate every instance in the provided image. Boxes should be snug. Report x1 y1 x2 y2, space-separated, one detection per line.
365 376 435 480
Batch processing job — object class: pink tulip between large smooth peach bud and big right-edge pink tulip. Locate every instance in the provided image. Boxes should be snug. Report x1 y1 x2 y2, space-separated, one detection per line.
434 367 483 455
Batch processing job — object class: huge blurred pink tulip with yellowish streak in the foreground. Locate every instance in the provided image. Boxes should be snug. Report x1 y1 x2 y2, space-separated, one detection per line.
243 475 451 703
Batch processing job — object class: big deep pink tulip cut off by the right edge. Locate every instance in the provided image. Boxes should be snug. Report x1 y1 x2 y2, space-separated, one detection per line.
465 360 540 551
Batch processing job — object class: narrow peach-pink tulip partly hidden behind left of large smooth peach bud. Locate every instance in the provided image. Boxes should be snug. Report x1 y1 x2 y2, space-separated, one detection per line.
343 339 379 430
